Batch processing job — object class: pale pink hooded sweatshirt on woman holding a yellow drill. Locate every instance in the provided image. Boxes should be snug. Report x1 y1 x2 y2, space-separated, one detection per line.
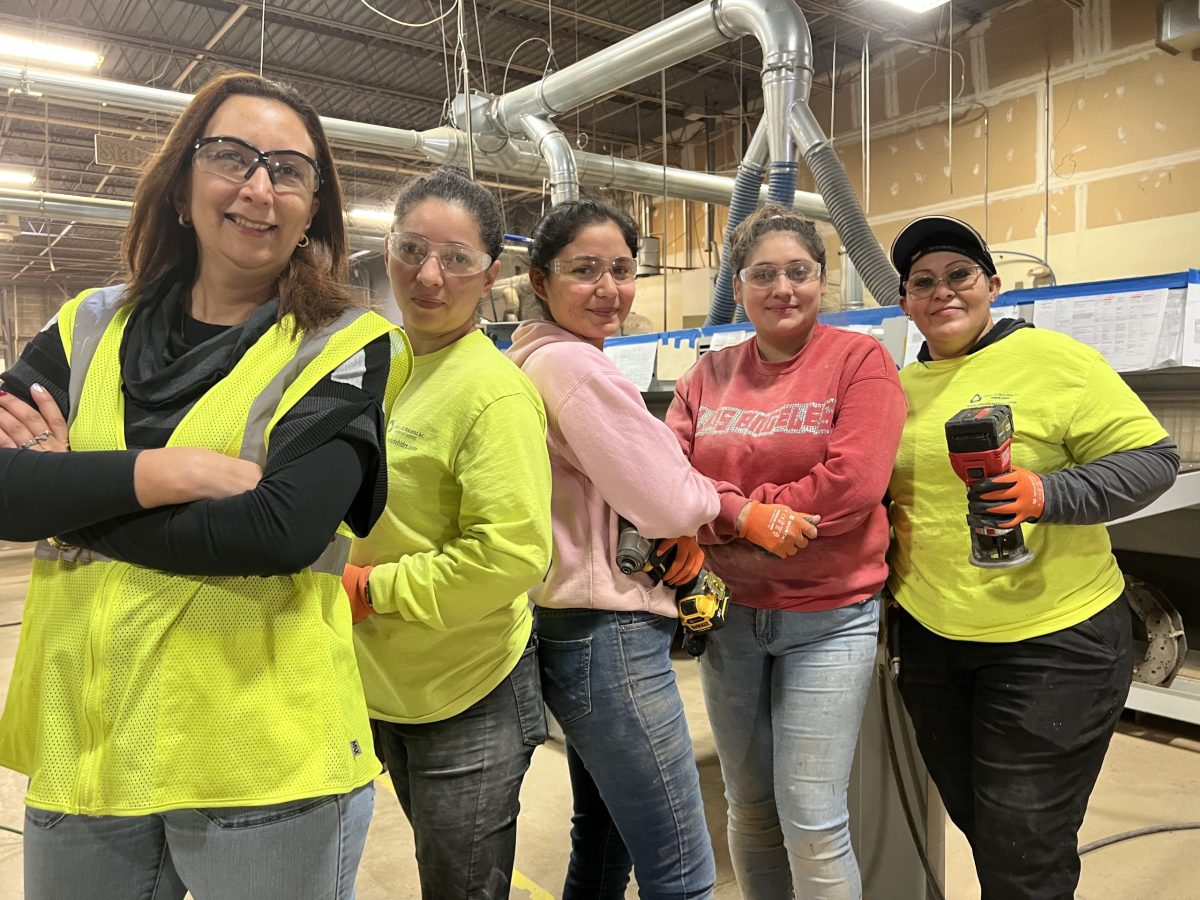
509 322 720 617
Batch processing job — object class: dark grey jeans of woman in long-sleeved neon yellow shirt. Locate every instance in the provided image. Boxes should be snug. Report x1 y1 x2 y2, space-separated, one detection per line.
372 640 546 900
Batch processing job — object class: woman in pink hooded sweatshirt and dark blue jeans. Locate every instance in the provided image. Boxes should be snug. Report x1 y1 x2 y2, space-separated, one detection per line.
509 200 718 900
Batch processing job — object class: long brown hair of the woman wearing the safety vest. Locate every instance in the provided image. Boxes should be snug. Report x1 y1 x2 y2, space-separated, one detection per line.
122 72 361 330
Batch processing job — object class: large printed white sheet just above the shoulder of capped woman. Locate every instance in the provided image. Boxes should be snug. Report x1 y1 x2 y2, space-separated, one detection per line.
1033 288 1168 372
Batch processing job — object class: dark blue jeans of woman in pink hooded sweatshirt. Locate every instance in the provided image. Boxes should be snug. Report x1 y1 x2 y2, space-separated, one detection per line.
534 608 716 900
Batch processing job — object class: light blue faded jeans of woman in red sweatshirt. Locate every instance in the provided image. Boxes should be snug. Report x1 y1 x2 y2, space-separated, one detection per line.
700 598 880 900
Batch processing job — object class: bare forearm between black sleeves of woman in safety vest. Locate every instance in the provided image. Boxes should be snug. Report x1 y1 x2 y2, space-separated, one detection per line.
133 446 263 509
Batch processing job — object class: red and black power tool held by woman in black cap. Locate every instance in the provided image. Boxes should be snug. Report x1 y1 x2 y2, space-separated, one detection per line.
946 403 1033 569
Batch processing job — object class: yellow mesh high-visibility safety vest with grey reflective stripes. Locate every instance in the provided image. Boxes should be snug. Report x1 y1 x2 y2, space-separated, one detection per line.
0 286 412 815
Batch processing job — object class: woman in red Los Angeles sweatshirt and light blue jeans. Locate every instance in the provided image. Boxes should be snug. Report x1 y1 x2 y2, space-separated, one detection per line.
667 205 905 900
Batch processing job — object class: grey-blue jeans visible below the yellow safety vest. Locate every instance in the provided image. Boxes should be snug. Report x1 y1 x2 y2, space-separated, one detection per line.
25 785 374 900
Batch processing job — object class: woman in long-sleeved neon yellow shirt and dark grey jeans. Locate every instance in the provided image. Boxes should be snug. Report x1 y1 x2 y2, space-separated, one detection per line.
346 168 551 900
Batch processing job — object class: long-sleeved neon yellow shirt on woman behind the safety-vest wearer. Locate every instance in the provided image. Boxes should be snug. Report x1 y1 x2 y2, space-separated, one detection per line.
350 331 551 722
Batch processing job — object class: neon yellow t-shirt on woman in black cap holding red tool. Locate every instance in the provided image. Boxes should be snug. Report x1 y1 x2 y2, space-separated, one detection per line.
888 329 1168 642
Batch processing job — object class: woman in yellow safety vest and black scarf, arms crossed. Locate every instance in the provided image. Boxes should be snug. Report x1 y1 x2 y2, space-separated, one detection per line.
0 74 410 900
